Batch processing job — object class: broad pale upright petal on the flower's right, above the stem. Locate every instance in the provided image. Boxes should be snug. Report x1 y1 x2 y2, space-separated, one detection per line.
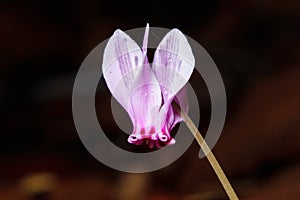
153 29 195 103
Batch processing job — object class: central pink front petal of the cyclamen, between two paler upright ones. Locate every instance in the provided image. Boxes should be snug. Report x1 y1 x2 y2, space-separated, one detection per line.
128 60 166 143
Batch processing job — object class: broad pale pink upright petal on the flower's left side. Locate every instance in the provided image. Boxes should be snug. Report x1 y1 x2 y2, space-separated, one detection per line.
102 29 144 119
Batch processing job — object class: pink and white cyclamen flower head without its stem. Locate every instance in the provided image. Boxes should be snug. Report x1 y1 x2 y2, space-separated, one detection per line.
102 24 195 148
